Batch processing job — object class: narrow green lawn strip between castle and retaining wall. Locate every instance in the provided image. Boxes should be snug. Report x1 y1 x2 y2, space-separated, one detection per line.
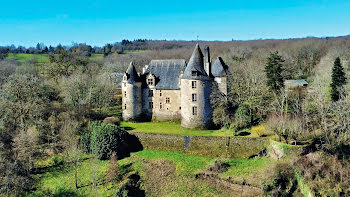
121 122 233 136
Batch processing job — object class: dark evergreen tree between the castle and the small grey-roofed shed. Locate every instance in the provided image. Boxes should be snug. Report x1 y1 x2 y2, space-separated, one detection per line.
265 51 284 92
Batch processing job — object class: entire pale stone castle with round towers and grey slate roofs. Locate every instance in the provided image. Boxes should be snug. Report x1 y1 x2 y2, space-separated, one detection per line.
122 44 228 129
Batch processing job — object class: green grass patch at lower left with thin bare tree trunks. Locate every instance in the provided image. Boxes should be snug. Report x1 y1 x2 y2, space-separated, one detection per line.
29 157 116 196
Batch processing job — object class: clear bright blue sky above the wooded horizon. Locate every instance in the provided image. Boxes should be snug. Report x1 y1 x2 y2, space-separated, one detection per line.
0 0 350 47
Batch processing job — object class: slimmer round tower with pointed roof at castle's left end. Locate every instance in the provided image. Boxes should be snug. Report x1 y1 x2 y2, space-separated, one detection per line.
122 62 142 120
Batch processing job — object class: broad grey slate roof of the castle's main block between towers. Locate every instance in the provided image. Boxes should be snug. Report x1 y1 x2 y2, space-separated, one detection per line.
144 59 186 90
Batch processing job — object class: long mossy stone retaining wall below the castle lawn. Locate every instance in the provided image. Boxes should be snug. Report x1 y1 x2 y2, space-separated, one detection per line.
132 132 270 158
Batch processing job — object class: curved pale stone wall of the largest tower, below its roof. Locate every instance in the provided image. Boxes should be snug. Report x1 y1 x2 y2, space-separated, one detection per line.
181 79 213 129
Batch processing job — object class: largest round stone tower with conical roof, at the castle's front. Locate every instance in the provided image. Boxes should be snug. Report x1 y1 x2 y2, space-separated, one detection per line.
180 44 213 129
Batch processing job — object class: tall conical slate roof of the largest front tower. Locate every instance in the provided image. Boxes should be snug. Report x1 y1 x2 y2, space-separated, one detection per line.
182 44 208 79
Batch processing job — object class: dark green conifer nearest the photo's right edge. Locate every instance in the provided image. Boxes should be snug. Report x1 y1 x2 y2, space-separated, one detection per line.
331 57 346 101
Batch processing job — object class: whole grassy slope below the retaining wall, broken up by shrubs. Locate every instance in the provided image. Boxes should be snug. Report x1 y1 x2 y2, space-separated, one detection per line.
29 150 273 196
